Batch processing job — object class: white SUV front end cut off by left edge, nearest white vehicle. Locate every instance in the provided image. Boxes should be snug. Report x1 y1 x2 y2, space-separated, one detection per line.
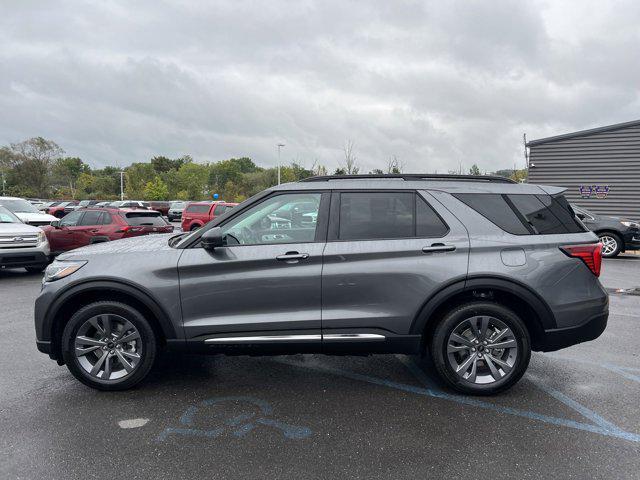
0 206 50 272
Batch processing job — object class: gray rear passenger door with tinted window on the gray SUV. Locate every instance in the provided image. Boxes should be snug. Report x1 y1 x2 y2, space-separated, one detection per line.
322 190 469 349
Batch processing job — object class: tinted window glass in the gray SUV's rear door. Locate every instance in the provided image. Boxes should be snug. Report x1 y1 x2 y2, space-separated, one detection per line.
338 192 449 240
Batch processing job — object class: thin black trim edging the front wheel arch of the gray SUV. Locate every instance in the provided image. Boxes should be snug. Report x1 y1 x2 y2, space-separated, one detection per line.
43 279 182 340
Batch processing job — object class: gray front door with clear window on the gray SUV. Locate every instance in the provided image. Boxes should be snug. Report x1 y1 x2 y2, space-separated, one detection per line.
179 192 329 351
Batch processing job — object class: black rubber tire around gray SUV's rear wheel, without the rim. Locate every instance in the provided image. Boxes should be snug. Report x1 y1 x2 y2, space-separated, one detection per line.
429 302 531 395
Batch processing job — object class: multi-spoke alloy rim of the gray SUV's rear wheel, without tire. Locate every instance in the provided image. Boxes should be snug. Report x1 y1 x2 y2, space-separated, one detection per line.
447 315 519 384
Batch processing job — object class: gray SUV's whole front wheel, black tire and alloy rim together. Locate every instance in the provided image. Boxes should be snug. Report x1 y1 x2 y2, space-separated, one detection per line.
62 301 158 390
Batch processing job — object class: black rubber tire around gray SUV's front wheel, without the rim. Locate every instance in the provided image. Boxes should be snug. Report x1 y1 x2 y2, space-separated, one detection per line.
62 301 158 390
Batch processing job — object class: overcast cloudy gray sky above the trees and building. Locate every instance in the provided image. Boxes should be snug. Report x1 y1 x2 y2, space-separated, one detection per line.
0 0 640 172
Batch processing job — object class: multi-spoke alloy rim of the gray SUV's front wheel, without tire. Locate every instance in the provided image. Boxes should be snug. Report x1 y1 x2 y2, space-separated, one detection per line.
75 314 143 380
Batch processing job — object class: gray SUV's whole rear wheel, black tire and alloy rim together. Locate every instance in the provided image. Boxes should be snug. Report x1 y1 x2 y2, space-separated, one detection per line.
429 302 531 395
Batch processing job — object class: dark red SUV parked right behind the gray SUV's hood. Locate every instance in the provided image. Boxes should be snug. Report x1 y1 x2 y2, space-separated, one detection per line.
42 208 173 255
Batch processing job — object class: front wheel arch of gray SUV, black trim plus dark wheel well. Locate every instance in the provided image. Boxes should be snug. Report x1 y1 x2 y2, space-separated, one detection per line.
44 280 177 361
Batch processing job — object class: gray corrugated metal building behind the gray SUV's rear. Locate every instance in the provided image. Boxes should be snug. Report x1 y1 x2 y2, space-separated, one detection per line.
527 120 640 219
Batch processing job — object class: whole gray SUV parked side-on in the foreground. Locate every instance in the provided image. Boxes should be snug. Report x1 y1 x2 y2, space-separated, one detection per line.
35 175 608 395
